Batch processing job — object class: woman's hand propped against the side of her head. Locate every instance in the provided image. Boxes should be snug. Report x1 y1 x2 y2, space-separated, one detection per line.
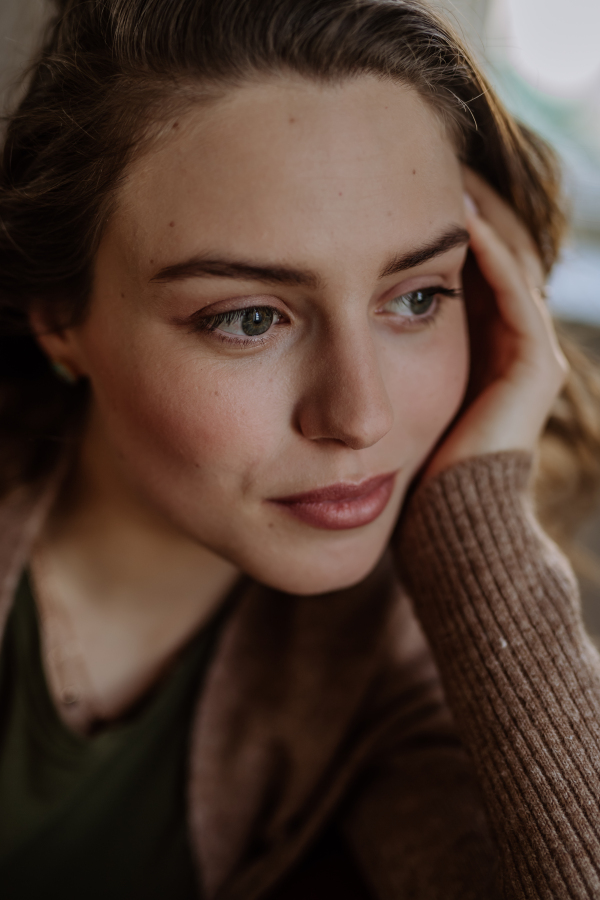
424 169 568 478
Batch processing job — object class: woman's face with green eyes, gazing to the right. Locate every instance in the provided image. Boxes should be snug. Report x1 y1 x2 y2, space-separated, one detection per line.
69 77 468 594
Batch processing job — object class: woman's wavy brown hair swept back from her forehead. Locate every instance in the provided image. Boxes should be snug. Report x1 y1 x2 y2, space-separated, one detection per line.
0 0 600 540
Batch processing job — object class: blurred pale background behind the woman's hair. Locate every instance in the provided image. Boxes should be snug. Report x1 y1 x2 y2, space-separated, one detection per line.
0 0 600 632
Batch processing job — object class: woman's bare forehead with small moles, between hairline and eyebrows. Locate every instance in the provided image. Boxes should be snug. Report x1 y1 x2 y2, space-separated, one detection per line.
114 77 462 274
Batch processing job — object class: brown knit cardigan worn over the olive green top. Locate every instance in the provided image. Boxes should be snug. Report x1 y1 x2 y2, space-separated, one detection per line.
0 453 600 900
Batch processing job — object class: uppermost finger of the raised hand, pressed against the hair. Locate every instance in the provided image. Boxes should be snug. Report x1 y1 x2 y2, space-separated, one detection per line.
463 166 545 289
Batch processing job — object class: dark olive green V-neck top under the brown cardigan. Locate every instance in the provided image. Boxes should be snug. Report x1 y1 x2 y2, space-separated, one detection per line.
0 573 230 900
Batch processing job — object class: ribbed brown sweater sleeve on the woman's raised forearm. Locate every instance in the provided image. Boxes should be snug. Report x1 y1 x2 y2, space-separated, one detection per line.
398 452 600 900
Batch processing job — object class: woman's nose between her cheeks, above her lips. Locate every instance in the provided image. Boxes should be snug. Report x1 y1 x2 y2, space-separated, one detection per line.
298 323 393 450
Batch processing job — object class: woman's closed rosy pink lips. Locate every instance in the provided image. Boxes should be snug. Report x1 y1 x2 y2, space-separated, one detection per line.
271 472 396 531
